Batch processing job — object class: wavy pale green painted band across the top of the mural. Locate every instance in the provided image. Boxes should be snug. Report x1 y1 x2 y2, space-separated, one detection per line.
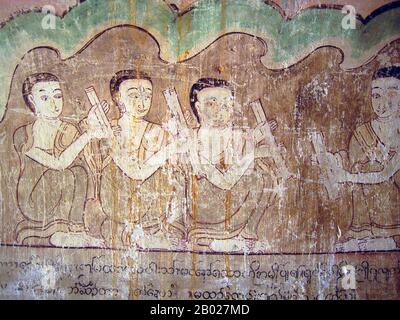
0 0 400 119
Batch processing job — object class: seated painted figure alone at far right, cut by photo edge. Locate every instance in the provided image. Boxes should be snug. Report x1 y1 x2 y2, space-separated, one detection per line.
312 66 400 250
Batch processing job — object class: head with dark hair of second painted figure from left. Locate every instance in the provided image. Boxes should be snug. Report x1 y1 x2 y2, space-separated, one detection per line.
110 70 153 118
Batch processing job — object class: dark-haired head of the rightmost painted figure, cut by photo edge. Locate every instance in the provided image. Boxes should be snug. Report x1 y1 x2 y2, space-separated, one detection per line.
372 66 400 118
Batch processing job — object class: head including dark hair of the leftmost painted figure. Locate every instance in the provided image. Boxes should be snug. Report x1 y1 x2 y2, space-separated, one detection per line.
22 73 63 119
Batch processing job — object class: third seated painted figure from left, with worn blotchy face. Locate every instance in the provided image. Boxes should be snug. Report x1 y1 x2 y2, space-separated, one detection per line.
177 78 286 251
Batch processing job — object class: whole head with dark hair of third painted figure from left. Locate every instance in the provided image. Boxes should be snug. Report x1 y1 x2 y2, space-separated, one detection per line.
190 78 234 127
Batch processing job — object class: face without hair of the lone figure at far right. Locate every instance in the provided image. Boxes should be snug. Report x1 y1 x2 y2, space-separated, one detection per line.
372 78 400 118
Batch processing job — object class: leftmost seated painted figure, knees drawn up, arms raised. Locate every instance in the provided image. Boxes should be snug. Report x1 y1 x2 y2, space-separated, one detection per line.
14 73 107 247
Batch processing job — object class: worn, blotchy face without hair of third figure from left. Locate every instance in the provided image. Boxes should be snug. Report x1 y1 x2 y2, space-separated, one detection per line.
195 87 233 127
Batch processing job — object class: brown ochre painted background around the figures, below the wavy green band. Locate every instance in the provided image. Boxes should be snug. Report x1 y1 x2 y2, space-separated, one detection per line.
1 27 400 253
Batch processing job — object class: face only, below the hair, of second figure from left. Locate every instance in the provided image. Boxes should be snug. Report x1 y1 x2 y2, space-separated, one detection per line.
118 79 153 118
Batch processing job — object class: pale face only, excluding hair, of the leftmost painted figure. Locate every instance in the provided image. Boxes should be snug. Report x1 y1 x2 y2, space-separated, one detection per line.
28 81 63 119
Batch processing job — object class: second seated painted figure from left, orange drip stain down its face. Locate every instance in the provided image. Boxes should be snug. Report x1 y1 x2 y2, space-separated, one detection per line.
100 70 188 248
